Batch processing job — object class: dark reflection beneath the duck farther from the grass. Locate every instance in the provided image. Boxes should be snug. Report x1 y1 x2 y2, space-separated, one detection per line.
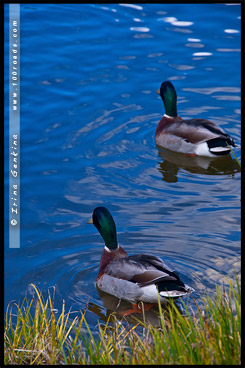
157 146 241 183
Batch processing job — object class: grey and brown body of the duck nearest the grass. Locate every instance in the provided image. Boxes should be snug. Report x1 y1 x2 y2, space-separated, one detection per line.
96 254 194 303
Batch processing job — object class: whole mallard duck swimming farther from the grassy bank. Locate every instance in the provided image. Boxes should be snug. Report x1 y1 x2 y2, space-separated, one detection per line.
155 81 236 157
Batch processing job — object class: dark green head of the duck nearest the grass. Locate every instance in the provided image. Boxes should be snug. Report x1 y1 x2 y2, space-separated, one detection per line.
88 207 117 250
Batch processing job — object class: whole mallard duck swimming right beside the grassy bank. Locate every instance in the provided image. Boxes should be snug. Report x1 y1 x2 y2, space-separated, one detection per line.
88 207 194 305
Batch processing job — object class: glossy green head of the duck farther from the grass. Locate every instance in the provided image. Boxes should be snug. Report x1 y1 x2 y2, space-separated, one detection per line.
157 81 177 117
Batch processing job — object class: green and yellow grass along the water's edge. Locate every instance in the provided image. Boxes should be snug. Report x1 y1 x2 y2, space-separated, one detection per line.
4 275 241 365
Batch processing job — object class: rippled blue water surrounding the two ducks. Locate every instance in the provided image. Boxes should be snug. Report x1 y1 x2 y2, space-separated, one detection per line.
5 4 241 326
